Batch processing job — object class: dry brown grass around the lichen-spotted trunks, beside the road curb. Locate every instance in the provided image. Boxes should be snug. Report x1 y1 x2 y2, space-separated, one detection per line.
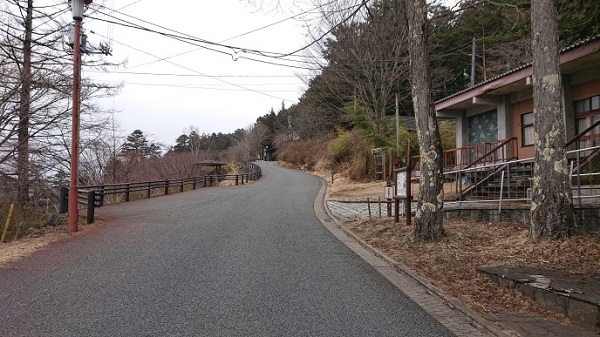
346 219 600 323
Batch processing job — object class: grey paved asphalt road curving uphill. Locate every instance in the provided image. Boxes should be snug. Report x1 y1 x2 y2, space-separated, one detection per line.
0 163 452 337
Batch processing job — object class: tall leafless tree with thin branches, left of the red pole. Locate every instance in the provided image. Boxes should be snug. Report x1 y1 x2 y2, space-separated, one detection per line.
0 0 118 206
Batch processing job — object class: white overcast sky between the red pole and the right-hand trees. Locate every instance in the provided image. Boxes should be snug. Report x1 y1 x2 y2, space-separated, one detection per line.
83 0 311 145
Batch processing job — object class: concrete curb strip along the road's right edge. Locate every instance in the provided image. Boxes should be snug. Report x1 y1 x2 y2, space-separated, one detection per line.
315 179 509 337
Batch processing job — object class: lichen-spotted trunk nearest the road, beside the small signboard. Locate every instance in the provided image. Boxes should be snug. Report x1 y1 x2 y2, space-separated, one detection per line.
404 0 444 241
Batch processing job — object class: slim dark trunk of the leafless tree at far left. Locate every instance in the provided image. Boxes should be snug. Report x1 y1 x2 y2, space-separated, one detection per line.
17 0 33 204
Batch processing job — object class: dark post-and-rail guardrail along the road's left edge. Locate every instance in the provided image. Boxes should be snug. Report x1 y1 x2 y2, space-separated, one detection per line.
59 163 262 223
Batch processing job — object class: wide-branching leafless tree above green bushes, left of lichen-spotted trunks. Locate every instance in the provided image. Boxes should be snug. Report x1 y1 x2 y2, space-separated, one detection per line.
304 0 408 135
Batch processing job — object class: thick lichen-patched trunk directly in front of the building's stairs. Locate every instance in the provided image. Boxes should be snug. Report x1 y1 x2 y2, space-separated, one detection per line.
530 0 575 242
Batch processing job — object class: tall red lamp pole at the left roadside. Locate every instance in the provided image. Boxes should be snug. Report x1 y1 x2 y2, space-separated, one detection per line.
69 18 81 232
